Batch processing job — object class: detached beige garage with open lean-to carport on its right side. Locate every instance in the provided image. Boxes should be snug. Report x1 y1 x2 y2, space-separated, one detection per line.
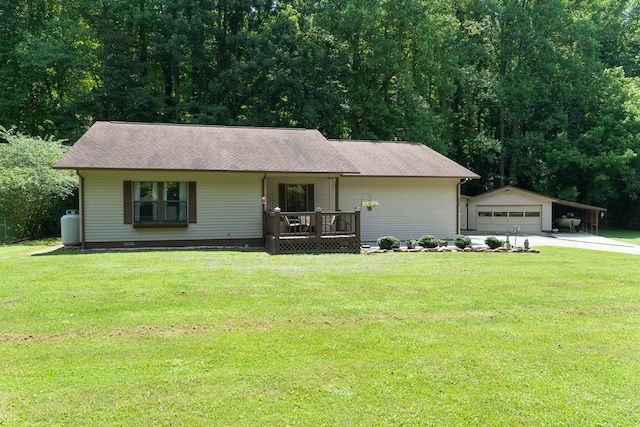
466 185 606 234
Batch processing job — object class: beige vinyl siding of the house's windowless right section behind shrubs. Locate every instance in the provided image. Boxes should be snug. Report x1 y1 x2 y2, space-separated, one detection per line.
340 177 459 242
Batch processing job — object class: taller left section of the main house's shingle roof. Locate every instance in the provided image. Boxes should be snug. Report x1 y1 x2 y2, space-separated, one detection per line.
56 122 357 173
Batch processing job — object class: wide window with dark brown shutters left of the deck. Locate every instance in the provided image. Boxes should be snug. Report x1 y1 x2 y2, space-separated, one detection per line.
124 181 196 227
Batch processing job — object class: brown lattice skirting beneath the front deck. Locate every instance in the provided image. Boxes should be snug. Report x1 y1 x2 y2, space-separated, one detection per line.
266 235 360 254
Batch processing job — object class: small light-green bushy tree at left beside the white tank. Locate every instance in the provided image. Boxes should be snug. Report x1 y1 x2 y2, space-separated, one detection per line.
0 126 78 238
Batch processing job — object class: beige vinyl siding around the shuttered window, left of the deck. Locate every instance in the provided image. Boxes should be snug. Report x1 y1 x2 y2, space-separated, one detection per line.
80 170 262 242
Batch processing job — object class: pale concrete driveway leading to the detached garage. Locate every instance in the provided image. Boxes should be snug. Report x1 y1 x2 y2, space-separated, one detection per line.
463 232 640 255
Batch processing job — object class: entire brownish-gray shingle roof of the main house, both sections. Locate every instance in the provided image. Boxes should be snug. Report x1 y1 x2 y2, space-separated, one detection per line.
56 122 478 178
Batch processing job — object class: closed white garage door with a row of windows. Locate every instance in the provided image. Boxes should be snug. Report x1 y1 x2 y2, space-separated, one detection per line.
477 205 542 233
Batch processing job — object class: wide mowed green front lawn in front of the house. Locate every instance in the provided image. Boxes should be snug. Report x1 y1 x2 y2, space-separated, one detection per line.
0 245 640 426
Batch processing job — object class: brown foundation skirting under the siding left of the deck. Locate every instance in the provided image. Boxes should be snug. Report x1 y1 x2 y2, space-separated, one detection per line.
83 239 264 249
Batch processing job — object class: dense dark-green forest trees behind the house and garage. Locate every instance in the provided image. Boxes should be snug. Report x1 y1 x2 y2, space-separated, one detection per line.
0 0 640 225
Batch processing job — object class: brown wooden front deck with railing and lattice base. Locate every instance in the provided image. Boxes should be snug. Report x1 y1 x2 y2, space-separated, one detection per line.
265 210 360 254
